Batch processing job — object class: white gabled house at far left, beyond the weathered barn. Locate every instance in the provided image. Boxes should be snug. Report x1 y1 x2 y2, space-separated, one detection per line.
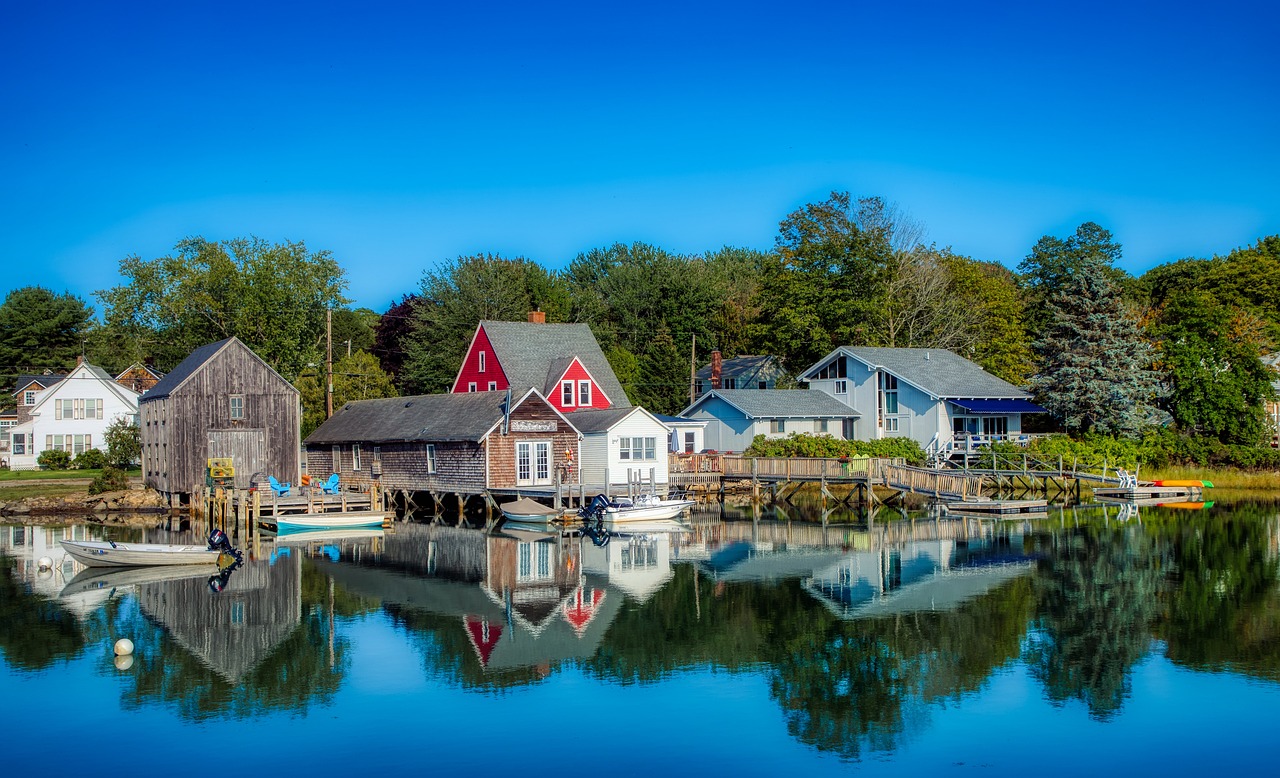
10 362 140 470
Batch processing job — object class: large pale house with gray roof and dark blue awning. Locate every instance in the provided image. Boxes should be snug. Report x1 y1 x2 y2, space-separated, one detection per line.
800 345 1044 452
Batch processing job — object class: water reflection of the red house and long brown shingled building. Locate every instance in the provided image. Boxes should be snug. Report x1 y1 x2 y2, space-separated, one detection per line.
314 523 621 671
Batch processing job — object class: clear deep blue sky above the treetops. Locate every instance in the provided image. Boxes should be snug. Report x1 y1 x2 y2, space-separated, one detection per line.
0 0 1280 311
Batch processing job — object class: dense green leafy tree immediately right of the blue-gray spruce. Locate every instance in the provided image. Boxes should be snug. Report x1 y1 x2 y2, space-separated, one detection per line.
1153 290 1272 444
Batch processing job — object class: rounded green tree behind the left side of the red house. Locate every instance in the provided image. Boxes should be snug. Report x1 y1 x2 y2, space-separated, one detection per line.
398 255 570 394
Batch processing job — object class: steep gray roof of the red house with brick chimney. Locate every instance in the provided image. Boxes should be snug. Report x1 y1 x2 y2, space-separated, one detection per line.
480 320 631 408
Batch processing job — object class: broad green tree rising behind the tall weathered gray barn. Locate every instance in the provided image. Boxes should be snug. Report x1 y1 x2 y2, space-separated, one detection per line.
97 238 347 377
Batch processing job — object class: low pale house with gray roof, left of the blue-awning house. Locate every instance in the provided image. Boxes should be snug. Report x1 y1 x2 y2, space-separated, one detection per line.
680 389 859 452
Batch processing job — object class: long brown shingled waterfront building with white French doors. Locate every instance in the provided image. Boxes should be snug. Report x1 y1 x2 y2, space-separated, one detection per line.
305 389 581 511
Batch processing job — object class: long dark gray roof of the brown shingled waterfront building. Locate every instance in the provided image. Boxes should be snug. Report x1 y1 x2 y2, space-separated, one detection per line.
303 392 520 445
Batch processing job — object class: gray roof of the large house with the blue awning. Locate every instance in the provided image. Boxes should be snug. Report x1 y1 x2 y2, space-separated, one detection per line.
801 345 1030 399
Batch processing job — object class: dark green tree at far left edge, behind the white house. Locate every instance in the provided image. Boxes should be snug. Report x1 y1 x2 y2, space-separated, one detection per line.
0 287 93 406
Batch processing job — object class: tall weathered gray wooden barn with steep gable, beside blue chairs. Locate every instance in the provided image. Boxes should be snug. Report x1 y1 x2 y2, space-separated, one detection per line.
138 338 302 500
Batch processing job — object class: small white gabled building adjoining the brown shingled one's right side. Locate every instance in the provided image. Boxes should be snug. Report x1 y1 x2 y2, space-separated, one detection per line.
568 406 671 494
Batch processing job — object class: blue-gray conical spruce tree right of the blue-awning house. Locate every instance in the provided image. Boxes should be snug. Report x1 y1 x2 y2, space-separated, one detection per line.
1032 260 1158 435
